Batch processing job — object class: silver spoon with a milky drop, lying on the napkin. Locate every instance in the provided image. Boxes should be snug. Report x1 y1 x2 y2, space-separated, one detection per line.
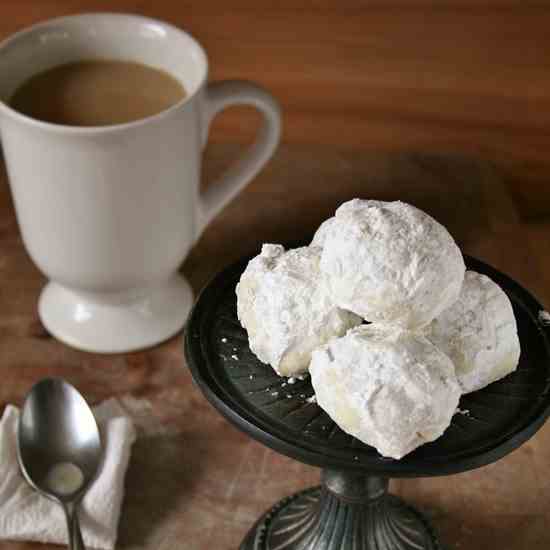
17 378 101 550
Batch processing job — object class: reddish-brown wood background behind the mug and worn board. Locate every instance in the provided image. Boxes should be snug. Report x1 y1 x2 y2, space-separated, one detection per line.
0 0 550 218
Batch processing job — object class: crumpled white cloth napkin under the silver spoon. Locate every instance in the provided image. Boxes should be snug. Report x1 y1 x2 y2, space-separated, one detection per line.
0 399 136 550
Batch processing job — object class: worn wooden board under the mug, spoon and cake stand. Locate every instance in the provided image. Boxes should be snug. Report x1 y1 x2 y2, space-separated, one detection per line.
0 144 550 550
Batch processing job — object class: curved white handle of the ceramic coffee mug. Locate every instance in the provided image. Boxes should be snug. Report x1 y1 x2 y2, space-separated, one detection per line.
197 80 281 239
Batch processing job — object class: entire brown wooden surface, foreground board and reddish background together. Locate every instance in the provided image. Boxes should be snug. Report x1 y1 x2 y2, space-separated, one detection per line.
0 0 550 550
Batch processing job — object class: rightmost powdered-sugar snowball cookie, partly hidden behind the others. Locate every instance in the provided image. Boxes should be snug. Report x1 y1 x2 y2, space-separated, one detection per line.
426 271 520 393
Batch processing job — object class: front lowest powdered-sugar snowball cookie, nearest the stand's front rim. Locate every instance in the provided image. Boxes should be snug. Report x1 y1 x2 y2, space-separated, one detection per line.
309 325 460 458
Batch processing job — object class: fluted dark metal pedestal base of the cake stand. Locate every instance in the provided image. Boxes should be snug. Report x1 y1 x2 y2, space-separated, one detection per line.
241 470 441 550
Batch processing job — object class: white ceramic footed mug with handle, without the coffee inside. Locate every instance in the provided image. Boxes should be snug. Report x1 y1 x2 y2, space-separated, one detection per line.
0 14 281 352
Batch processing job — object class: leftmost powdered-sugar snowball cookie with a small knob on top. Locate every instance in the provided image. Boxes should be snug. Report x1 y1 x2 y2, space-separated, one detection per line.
237 244 362 376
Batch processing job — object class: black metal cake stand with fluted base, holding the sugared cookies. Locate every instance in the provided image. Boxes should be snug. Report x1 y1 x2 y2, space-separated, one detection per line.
185 258 550 550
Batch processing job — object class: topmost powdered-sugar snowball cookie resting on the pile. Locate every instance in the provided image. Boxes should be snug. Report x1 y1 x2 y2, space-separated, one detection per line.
316 199 466 329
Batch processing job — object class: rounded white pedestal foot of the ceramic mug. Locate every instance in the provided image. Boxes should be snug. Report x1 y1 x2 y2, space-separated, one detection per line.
38 274 193 353
